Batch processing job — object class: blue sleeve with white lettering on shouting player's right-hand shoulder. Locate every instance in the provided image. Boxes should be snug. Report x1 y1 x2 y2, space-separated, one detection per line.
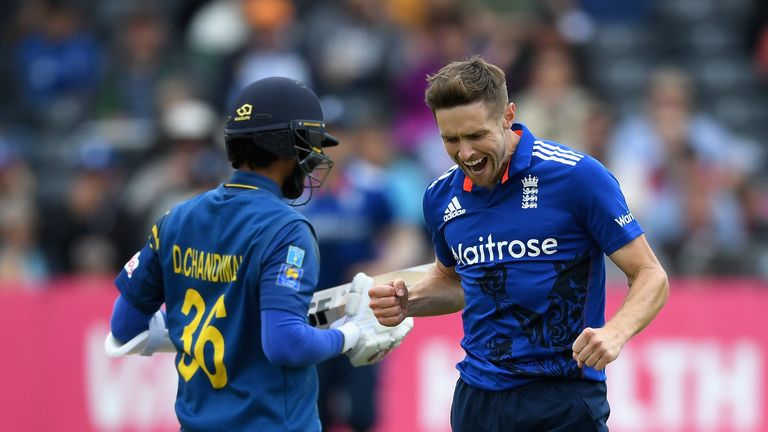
570 157 643 255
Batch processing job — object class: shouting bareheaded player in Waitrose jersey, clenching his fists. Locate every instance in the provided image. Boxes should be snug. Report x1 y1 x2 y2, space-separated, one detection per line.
370 57 669 432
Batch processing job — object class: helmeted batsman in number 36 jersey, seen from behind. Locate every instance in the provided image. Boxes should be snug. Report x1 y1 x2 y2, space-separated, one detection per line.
107 77 408 432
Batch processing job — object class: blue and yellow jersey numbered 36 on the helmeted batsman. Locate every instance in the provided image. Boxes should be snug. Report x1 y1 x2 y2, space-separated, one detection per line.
115 171 320 432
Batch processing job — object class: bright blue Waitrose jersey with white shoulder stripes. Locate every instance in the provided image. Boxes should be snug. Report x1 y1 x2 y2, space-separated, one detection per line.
423 124 643 390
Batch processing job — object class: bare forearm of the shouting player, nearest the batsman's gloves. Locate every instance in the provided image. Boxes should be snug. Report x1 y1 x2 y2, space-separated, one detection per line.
408 267 464 317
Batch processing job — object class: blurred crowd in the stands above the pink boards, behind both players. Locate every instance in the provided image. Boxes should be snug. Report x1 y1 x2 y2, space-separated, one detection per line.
0 0 768 289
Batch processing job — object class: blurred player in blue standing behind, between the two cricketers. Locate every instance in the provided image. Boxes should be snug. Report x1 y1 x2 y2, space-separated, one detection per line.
299 107 426 431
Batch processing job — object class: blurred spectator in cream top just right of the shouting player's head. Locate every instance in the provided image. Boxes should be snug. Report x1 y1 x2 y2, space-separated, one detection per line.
511 45 590 151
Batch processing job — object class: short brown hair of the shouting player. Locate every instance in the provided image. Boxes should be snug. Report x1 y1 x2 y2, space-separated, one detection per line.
424 56 509 120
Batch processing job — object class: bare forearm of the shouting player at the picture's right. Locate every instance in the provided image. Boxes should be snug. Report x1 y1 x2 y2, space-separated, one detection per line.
605 266 669 341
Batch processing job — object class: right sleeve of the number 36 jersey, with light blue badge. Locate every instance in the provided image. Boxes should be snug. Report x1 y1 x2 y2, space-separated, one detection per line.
259 220 320 316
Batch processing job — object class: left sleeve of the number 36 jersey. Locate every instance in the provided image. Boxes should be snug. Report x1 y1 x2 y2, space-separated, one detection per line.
115 216 165 314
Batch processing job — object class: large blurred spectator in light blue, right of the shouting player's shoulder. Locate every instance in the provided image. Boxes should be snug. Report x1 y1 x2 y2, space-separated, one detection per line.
608 68 759 274
